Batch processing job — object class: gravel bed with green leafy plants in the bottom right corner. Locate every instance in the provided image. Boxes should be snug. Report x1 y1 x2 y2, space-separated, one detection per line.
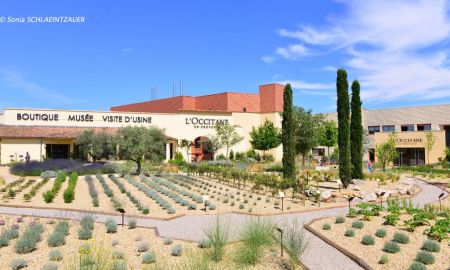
307 200 450 270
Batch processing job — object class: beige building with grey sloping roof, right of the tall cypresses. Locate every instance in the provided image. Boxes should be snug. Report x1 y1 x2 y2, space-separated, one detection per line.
320 104 450 166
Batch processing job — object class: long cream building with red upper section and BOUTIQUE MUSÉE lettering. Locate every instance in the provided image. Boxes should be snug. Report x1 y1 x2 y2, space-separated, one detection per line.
0 84 284 164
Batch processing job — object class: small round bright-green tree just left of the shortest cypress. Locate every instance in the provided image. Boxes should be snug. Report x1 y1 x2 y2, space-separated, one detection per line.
250 119 281 158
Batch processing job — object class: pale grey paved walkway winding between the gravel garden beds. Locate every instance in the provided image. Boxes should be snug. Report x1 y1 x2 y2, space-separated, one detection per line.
0 179 442 270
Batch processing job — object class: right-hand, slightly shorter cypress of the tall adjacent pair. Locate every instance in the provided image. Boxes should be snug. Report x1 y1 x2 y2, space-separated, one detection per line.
350 80 364 179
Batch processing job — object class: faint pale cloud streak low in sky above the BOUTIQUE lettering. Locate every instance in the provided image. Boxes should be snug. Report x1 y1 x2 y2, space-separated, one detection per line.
0 67 78 104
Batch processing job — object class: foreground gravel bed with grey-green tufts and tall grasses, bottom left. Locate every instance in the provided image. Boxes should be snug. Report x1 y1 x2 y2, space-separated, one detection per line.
0 215 308 270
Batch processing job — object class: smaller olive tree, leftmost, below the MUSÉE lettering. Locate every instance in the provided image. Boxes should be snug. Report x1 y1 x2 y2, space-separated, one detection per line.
75 129 114 163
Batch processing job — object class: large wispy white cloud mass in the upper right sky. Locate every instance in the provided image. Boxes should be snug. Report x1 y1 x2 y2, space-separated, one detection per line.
277 0 450 102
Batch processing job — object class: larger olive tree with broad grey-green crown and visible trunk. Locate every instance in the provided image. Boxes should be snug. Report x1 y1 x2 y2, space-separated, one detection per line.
116 126 166 174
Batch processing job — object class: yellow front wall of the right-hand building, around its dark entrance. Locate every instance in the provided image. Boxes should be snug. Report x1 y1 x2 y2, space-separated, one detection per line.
374 130 445 163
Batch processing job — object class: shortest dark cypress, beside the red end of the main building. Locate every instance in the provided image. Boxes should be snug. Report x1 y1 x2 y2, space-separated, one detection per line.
281 84 295 179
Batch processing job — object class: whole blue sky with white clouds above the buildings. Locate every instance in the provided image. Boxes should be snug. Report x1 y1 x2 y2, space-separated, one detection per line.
0 0 450 112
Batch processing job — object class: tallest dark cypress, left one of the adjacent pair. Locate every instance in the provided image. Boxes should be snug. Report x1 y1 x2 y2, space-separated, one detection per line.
336 68 351 188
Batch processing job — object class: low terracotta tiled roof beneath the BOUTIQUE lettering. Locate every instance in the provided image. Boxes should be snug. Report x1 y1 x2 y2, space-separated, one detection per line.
0 125 177 140
